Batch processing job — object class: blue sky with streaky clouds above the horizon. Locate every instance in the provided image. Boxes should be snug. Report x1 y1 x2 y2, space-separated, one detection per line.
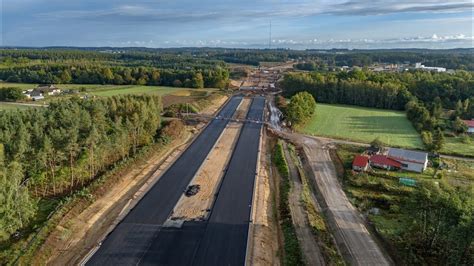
0 0 474 49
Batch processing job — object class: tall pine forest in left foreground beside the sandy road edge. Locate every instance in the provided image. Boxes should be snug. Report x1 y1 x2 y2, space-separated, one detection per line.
0 95 162 240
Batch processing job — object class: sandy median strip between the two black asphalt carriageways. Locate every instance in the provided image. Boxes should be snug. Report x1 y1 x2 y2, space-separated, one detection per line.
170 98 251 221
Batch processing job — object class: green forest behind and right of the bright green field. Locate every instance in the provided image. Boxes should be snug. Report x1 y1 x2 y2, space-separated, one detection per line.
280 69 474 151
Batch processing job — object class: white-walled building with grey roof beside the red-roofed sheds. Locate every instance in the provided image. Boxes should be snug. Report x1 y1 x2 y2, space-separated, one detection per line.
386 148 428 173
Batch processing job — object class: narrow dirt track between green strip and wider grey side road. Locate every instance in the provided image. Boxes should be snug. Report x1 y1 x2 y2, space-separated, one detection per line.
284 145 325 265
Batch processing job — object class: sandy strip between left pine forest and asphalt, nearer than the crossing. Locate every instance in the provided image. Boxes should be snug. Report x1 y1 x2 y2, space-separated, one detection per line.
39 132 192 265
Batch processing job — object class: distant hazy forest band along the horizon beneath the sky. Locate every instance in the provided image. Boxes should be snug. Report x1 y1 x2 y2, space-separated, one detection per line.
4 47 474 71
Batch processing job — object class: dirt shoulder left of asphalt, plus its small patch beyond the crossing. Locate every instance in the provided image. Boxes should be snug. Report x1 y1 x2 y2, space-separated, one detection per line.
36 96 228 265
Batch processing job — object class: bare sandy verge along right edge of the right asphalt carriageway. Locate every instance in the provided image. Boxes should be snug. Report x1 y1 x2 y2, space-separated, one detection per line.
247 131 280 266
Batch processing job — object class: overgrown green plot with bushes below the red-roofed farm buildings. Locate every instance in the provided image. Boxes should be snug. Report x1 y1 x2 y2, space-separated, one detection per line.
337 145 474 265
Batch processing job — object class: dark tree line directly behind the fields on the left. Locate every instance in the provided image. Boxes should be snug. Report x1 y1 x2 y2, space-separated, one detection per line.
0 65 229 88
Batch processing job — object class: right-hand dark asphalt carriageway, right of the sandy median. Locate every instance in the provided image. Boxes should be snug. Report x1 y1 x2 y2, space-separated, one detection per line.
193 97 265 265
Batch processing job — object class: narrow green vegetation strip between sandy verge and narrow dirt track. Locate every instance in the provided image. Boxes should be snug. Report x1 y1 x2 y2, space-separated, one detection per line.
272 141 304 265
